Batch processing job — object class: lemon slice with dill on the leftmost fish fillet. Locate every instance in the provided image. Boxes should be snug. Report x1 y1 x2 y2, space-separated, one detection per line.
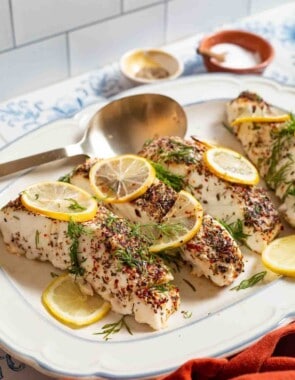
21 181 97 222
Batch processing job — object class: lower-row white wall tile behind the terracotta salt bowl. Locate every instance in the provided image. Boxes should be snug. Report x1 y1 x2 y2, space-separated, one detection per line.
166 0 248 41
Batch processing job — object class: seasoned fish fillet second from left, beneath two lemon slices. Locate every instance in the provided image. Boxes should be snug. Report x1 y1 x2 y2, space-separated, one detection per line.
70 159 243 286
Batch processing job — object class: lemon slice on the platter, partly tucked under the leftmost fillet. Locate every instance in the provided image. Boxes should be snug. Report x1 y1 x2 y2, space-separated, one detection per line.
42 275 111 327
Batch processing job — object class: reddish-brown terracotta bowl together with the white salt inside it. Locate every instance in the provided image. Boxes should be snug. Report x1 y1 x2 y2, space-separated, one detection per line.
198 30 274 74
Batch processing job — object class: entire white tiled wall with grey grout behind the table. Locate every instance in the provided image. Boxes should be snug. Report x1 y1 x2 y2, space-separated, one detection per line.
0 0 294 101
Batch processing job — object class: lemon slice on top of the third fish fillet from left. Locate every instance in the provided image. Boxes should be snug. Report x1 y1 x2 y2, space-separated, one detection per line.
204 147 259 185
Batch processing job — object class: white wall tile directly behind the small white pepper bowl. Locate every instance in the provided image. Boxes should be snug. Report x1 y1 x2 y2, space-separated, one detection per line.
69 4 164 75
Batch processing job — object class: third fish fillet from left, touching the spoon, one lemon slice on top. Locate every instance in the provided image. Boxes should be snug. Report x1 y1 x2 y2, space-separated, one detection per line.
139 137 281 253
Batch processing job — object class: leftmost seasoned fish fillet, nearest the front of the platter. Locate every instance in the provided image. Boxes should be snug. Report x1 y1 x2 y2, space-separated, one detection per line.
0 198 179 329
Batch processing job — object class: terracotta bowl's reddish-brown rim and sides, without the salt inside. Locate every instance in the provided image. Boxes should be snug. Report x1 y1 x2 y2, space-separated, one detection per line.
198 30 274 74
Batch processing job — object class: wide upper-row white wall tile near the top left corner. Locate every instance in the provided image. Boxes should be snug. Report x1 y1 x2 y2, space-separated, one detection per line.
12 0 121 45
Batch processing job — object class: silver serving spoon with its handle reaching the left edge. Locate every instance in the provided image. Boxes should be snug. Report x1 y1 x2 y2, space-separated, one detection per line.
0 94 187 177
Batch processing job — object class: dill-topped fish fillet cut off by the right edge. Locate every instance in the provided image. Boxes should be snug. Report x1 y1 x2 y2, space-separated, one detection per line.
226 92 295 227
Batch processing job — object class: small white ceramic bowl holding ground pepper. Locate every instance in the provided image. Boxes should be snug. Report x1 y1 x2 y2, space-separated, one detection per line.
120 49 183 84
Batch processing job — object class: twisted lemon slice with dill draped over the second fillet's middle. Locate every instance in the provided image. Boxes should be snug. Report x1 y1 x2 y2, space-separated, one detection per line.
150 190 203 252
